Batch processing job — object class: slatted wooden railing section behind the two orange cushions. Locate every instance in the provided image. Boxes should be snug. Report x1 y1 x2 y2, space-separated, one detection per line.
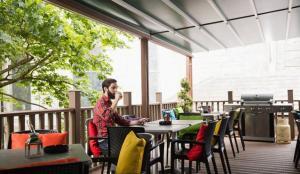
0 108 76 149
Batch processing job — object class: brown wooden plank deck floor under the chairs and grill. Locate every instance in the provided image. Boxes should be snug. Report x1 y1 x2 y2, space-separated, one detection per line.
92 139 300 174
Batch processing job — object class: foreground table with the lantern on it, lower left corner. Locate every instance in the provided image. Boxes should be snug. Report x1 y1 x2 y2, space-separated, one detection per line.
0 144 92 174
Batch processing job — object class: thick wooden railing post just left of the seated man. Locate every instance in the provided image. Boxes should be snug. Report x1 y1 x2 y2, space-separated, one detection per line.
69 90 84 144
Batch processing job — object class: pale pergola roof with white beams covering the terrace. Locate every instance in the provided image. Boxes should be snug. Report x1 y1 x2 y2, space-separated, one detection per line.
49 0 300 55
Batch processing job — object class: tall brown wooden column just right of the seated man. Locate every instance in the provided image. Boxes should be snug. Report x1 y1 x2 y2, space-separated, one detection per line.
141 38 150 118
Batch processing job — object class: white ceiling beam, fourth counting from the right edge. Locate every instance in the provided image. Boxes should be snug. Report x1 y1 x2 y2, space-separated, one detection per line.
161 0 226 48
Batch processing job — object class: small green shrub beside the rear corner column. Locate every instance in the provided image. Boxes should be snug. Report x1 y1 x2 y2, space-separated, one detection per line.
177 79 193 112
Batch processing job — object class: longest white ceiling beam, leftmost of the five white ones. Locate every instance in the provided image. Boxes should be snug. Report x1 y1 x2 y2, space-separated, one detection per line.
112 0 208 51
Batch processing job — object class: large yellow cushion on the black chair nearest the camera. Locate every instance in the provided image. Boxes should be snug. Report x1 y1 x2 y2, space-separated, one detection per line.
116 131 146 174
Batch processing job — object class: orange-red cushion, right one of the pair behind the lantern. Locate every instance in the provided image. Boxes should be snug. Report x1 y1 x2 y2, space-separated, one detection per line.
39 132 68 147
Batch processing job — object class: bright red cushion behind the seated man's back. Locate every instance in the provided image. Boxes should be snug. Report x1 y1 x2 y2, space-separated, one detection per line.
88 121 101 157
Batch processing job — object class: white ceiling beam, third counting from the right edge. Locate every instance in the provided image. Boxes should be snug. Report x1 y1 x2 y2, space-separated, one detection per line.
206 0 245 45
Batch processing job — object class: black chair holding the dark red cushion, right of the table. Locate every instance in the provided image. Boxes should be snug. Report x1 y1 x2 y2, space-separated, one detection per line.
171 121 217 173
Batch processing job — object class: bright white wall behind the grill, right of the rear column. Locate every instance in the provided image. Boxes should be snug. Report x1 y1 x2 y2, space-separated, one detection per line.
193 38 300 100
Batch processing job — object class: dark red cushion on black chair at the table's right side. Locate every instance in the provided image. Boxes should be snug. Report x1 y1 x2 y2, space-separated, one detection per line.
187 125 208 161
